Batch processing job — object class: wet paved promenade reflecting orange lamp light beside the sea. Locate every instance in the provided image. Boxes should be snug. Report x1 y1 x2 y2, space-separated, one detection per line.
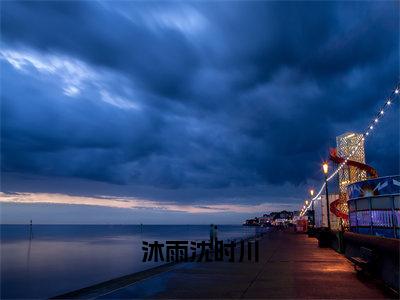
100 232 385 299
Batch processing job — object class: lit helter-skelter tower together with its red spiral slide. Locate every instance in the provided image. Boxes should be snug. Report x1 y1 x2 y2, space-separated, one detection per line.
329 132 378 220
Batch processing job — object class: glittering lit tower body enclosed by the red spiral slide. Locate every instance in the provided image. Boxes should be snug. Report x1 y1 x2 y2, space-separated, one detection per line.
336 132 367 197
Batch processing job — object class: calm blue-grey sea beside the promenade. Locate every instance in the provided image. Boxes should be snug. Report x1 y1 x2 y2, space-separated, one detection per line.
0 225 256 299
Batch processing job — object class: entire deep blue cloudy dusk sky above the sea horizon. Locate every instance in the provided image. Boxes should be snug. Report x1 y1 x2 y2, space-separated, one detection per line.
0 1 400 224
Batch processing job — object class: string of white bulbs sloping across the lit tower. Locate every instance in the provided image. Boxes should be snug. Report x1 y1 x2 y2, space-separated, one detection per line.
300 84 400 216
